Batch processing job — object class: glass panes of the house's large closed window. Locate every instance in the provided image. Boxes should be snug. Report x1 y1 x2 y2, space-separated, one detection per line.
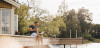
1 9 11 34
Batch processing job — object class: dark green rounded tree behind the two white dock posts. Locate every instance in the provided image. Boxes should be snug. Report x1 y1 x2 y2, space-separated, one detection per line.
59 9 81 38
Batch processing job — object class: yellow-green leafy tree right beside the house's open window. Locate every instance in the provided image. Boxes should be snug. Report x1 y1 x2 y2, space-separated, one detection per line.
15 5 29 34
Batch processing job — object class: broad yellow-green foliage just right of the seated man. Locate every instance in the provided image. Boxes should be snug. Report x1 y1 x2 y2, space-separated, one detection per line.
39 16 66 37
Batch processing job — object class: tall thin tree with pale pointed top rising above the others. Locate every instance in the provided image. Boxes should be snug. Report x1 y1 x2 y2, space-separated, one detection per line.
57 0 68 38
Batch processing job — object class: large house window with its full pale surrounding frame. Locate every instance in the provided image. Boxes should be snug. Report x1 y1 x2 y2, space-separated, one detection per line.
0 8 11 34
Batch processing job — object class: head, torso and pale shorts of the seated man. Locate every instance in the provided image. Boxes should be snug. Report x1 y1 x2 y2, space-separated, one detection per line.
29 21 38 37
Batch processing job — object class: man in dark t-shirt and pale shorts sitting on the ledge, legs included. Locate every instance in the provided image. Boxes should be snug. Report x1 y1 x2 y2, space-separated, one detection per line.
29 21 43 48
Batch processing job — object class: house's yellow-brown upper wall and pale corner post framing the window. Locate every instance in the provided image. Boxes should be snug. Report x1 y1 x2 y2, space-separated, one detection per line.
0 1 15 35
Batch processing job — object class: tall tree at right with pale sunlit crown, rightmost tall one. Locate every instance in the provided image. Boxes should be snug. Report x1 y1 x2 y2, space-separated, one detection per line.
77 7 92 34
